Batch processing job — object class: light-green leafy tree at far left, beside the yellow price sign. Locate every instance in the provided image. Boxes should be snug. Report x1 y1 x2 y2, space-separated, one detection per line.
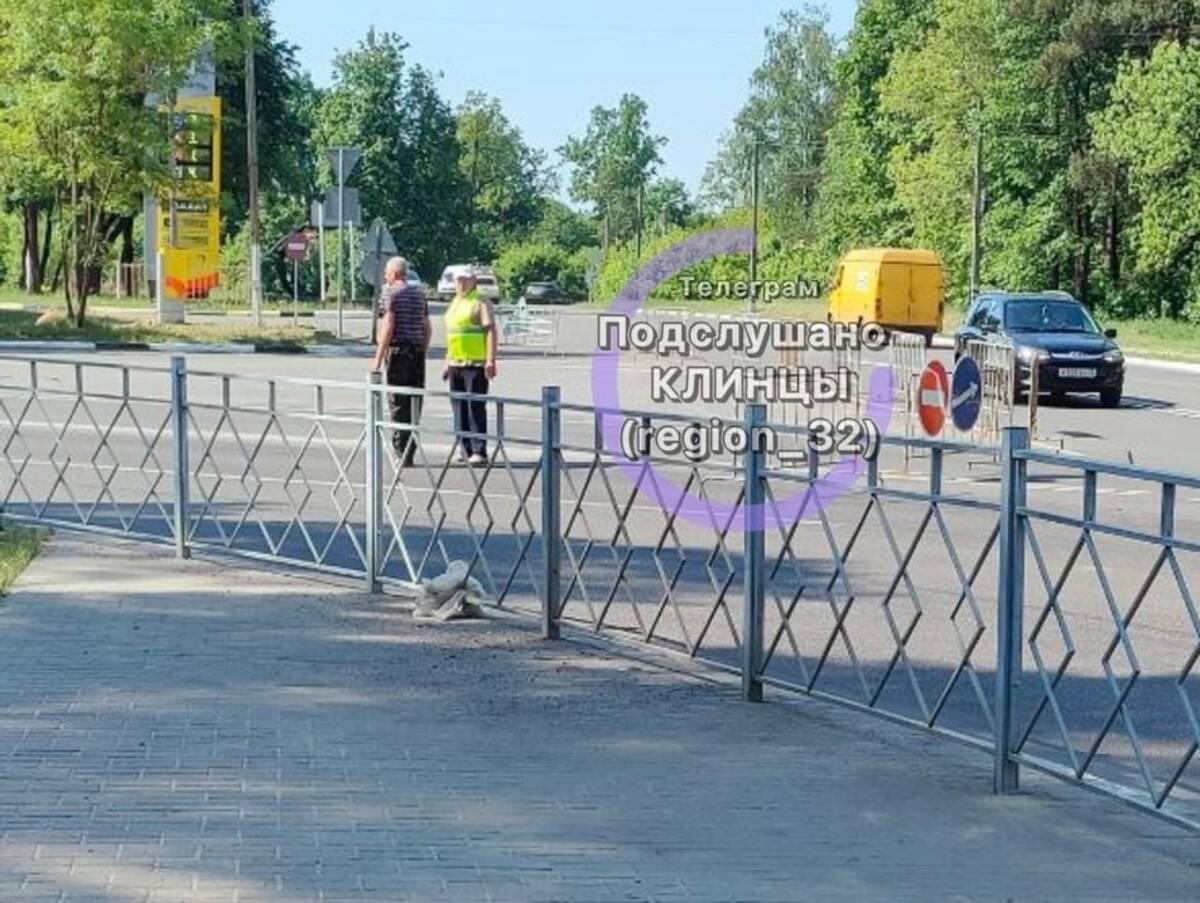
0 0 224 324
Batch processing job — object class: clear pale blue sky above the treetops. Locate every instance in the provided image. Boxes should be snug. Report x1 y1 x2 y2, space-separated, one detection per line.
274 0 857 189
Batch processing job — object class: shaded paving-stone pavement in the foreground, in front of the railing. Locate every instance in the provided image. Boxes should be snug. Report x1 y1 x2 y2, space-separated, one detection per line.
0 534 1200 903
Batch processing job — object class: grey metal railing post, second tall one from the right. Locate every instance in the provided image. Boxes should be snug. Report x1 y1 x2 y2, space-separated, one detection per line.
742 403 768 702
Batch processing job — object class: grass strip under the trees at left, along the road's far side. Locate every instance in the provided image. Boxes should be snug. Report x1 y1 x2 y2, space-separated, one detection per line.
0 310 334 347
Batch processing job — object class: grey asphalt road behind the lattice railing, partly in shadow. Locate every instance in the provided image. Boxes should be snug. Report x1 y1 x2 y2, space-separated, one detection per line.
0 313 1200 815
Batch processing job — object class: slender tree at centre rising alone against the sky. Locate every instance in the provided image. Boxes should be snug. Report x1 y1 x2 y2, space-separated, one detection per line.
558 94 666 241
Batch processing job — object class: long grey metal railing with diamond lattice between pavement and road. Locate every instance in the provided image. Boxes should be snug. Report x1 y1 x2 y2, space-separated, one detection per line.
0 358 1200 829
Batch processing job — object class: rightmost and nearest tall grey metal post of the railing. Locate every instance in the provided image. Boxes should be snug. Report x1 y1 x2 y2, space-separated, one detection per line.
992 426 1030 794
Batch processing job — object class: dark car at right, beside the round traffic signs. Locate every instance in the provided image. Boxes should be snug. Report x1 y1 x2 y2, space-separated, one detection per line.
954 292 1124 407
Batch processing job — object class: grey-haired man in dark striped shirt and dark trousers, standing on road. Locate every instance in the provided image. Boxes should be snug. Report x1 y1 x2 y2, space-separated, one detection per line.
372 257 433 467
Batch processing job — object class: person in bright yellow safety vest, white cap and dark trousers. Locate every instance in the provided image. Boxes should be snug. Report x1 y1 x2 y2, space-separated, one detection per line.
442 270 497 466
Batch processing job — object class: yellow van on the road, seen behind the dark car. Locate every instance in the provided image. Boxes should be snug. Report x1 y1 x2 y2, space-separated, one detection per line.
829 247 946 347
